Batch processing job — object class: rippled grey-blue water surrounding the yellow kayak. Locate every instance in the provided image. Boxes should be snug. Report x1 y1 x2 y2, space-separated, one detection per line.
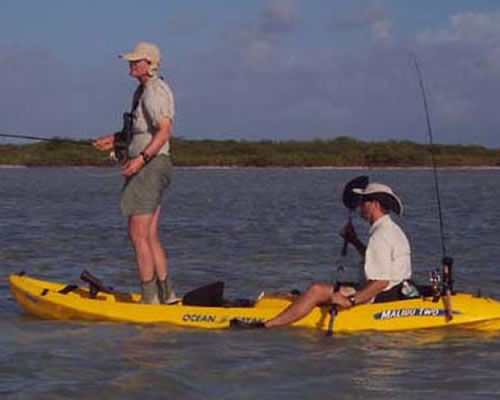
0 168 500 400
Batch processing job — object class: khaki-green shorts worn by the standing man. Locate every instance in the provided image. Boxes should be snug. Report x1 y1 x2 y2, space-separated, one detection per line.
120 154 172 217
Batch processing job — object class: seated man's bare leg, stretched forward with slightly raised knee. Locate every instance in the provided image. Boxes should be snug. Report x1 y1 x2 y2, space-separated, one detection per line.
265 283 333 328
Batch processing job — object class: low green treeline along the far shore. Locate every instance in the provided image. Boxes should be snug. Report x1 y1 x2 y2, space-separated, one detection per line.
0 136 500 167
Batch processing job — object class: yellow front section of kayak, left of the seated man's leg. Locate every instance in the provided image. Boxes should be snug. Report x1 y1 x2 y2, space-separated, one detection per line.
9 275 300 329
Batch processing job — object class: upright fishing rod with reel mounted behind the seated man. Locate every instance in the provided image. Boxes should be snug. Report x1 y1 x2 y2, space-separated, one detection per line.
412 54 453 321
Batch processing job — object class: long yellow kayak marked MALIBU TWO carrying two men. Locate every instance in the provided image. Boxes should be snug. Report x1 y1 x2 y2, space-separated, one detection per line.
9 274 500 332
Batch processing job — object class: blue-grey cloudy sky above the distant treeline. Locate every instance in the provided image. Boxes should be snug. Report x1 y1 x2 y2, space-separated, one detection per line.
0 0 500 148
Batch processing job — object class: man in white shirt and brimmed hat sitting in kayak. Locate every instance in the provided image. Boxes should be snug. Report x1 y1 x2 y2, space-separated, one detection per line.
230 182 411 328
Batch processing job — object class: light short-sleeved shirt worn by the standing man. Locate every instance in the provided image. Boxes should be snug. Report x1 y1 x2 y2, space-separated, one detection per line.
128 77 175 157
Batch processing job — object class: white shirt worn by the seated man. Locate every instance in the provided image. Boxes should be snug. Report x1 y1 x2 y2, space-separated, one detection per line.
365 215 411 291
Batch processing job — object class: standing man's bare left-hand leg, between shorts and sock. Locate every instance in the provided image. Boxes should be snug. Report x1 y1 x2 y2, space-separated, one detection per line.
128 215 155 282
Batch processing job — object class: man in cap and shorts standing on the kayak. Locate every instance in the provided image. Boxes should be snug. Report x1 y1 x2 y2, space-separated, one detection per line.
93 42 176 304
